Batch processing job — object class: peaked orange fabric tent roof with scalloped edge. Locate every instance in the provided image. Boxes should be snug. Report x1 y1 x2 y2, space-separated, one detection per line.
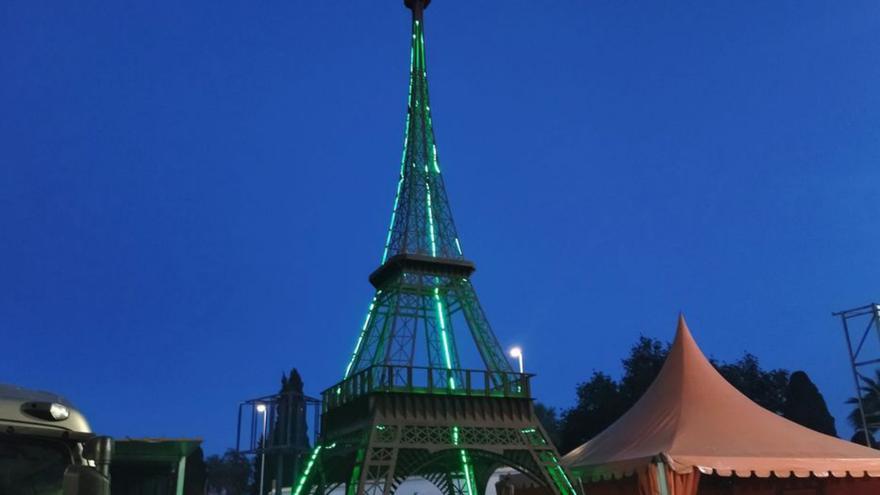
563 316 880 480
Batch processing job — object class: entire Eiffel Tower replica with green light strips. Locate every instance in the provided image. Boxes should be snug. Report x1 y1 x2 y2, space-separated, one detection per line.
292 0 576 495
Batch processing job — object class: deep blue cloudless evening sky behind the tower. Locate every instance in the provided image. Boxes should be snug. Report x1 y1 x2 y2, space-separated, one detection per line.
0 0 880 452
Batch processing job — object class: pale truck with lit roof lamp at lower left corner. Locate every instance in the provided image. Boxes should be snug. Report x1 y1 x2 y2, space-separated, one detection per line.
0 384 113 495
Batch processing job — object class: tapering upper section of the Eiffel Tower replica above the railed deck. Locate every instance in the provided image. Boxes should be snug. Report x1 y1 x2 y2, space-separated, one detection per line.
344 0 513 388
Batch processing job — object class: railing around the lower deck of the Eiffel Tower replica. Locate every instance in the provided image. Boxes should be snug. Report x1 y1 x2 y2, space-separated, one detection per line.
322 365 532 411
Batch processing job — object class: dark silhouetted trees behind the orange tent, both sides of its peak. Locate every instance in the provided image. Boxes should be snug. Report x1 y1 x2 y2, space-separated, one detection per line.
535 336 840 453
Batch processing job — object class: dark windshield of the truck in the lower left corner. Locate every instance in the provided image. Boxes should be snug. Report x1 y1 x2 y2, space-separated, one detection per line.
0 435 71 495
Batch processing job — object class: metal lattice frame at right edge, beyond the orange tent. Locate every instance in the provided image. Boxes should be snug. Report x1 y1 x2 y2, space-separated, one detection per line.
832 303 880 447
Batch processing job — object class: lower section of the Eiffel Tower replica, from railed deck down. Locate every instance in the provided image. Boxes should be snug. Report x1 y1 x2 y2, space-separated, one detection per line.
293 366 576 495
